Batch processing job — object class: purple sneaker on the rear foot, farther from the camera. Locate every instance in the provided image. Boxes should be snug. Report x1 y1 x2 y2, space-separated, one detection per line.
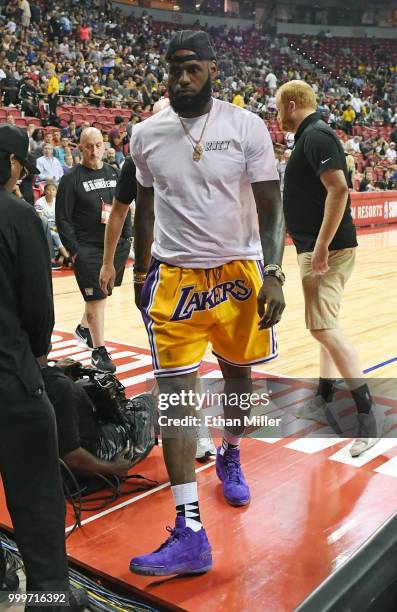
216 448 251 506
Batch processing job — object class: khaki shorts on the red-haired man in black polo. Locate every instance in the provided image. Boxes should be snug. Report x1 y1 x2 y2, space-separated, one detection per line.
298 248 356 330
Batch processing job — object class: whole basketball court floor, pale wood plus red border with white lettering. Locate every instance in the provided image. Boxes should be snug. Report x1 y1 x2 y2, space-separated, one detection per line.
0 226 397 612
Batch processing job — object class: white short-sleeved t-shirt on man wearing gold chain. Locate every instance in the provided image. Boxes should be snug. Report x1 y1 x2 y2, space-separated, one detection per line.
131 99 278 268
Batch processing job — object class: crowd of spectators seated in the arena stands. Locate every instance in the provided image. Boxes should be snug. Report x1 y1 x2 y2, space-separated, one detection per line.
0 0 397 190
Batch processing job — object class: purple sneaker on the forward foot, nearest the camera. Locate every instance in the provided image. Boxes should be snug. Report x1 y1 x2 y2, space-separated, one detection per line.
130 516 212 576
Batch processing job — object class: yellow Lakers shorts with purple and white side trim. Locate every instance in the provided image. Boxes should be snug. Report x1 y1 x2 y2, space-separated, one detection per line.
141 261 277 376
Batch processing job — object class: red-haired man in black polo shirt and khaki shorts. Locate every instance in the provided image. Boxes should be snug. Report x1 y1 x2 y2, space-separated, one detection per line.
276 81 384 457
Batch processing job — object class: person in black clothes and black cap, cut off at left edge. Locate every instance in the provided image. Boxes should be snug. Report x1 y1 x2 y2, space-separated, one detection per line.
0 125 80 610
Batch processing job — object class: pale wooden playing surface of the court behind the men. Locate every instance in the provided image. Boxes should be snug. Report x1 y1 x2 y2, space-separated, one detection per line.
54 226 397 378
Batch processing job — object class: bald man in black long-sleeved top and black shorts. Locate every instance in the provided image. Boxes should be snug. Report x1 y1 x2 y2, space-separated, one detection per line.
56 128 131 372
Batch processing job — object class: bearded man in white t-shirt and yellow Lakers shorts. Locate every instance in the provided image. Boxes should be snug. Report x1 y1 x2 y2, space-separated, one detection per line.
100 30 285 575
